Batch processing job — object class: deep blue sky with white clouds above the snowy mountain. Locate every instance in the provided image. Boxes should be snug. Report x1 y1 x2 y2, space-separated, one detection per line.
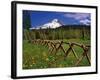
23 10 91 27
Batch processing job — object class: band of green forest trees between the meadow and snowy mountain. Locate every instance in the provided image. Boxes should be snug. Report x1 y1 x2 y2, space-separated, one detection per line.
24 25 90 40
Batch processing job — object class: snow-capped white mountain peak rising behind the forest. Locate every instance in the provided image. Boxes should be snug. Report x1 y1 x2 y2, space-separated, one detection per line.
30 19 63 30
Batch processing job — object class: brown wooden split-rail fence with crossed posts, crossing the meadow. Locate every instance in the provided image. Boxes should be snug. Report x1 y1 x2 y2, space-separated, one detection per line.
30 40 91 66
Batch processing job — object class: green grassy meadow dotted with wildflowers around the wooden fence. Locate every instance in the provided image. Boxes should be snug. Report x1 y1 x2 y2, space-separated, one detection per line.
22 39 90 69
